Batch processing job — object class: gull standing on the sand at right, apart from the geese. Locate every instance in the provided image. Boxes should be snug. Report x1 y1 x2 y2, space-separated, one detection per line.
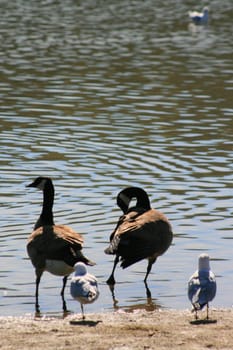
188 254 217 320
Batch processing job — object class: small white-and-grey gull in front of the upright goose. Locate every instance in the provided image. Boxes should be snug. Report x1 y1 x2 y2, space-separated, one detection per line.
70 262 99 320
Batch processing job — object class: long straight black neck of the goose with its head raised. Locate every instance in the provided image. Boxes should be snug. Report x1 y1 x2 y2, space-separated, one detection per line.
35 179 54 229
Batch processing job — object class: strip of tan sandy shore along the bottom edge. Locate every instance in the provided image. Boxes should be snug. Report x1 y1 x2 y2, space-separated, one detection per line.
0 309 233 350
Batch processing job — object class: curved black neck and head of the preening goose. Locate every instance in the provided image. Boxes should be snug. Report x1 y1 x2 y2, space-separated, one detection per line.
117 187 151 214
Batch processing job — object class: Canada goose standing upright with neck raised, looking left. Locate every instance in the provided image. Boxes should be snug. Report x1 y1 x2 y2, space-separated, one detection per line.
27 177 94 312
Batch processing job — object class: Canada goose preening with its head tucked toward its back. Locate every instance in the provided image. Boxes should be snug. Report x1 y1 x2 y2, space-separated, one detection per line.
105 187 173 287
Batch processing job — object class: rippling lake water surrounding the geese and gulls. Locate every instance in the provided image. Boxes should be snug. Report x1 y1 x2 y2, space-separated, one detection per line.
0 0 233 315
